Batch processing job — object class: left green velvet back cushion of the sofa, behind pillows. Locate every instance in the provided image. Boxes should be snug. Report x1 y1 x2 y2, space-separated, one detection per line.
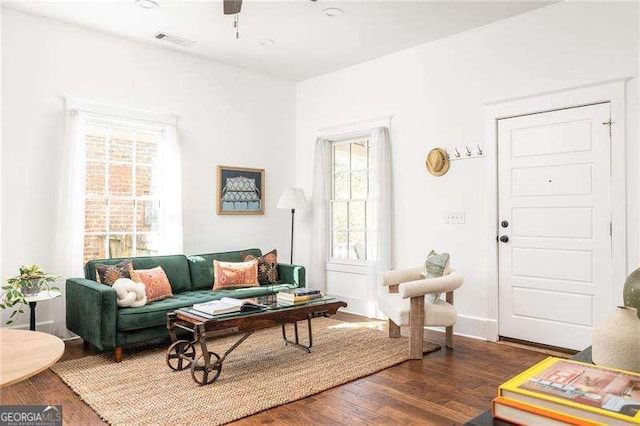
84 254 194 294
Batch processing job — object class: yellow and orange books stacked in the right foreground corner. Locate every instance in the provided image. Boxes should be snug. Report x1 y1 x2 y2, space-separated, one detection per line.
492 355 640 425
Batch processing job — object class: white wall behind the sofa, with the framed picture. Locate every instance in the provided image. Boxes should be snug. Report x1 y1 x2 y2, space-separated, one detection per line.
2 8 296 329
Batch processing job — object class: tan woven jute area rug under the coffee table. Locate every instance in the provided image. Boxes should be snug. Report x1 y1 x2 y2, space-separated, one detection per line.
52 318 440 425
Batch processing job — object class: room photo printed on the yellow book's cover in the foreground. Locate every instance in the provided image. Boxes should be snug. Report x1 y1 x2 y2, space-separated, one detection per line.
518 360 640 418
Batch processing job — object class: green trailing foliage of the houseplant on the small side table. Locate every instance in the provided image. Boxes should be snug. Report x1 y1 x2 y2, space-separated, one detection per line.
0 265 60 325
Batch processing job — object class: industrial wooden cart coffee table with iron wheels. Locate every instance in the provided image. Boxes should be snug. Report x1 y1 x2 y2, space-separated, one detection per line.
166 297 347 385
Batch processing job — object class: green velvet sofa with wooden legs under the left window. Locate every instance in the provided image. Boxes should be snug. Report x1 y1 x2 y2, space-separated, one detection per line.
66 249 305 362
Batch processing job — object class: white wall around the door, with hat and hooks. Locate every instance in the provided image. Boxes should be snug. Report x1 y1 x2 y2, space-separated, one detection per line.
296 2 640 337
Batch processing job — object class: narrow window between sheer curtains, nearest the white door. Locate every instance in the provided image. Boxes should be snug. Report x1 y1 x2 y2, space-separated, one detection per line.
330 139 369 262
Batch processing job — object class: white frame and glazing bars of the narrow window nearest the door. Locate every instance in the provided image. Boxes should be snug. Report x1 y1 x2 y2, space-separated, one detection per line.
327 134 371 262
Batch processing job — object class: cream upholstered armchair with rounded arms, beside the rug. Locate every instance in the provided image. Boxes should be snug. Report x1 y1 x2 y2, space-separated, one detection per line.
378 267 464 359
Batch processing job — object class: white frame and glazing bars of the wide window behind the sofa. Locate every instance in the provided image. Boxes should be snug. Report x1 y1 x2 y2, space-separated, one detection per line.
83 114 166 263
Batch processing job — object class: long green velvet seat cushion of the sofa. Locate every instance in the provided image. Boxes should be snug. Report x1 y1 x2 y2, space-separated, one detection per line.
117 284 295 331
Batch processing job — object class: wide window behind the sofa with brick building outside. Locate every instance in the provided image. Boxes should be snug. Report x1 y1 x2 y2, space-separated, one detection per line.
84 119 164 262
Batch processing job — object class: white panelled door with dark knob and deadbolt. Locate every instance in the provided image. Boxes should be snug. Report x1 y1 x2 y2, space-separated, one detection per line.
498 103 613 350
